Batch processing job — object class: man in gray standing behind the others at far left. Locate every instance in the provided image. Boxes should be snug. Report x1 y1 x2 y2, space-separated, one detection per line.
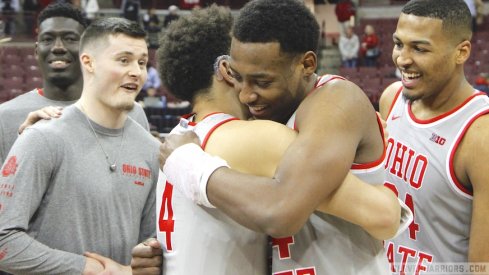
0 2 149 165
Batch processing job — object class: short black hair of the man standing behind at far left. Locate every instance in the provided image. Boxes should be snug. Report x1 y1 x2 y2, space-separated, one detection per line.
37 2 88 28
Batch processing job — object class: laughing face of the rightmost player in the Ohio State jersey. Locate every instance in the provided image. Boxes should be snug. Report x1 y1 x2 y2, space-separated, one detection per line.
392 14 464 100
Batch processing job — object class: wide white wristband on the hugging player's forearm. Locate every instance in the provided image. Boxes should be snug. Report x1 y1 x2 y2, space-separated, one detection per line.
163 143 229 208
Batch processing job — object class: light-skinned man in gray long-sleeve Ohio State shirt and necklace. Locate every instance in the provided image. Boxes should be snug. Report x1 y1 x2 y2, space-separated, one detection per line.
0 18 159 274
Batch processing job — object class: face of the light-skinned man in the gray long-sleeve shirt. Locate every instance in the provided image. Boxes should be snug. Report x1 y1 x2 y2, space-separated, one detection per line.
80 34 148 110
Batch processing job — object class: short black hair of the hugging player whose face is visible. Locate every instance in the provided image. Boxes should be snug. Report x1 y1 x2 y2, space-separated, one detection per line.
233 0 319 54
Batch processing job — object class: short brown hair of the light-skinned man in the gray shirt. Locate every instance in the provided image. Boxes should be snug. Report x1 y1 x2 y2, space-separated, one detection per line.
80 17 146 51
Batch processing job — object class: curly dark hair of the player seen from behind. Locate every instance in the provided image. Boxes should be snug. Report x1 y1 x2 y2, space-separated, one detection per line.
157 4 233 102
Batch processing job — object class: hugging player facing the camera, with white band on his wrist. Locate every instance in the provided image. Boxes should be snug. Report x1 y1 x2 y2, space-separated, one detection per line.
153 0 412 274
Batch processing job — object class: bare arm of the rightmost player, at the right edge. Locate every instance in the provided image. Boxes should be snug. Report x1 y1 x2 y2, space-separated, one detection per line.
455 115 489 263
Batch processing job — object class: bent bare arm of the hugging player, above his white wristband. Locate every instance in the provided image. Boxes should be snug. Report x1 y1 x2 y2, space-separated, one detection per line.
207 82 386 237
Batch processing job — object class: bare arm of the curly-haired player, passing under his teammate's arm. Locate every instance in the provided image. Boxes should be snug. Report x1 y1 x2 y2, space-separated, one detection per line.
206 120 400 240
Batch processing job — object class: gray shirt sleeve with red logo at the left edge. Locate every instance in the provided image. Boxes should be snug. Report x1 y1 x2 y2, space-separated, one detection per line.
0 129 85 274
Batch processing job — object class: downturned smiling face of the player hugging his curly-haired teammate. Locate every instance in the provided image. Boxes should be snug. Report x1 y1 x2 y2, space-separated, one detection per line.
229 38 306 123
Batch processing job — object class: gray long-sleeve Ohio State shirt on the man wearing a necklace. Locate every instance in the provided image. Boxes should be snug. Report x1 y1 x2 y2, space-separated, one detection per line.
0 105 159 274
